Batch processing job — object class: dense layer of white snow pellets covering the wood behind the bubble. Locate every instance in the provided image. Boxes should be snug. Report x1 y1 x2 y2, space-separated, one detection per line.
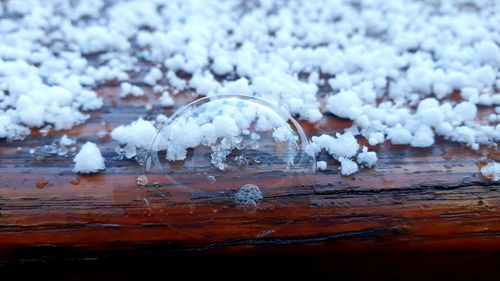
0 0 500 175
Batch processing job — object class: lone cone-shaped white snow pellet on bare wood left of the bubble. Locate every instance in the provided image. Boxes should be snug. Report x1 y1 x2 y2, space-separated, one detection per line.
73 142 106 174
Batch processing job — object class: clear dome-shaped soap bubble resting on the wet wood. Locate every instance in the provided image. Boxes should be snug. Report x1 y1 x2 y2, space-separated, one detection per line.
145 95 316 237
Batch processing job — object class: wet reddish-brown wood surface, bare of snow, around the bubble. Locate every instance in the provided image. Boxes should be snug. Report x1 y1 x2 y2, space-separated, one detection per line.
0 86 500 278
